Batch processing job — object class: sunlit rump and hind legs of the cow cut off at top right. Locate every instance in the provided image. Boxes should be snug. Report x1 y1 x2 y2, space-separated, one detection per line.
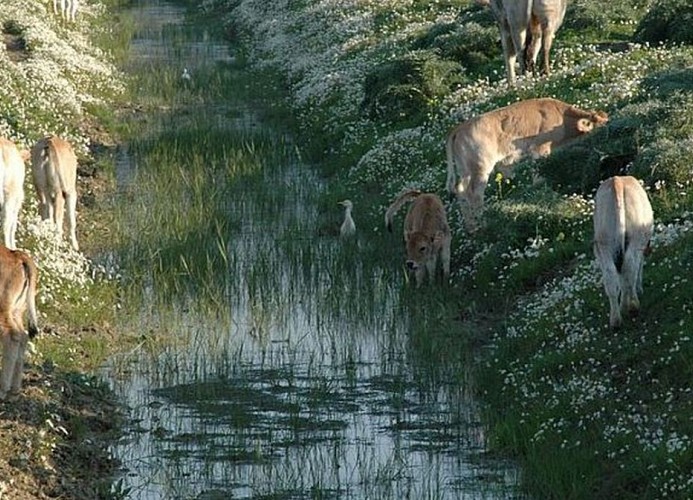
526 0 568 75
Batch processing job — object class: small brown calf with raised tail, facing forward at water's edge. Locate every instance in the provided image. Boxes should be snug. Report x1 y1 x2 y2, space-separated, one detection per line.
385 189 452 286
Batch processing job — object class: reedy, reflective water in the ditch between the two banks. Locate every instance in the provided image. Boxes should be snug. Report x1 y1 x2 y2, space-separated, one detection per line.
104 1 516 499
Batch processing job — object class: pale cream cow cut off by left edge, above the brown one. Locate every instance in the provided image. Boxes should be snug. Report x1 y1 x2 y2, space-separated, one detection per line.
0 137 26 250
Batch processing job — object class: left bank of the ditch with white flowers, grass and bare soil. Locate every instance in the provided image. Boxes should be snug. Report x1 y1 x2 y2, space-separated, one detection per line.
0 0 137 499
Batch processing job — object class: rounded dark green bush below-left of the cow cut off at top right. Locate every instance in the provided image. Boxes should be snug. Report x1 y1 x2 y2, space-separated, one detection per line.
361 51 463 122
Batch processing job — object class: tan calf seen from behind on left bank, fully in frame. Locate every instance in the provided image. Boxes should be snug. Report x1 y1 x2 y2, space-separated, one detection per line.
31 135 79 250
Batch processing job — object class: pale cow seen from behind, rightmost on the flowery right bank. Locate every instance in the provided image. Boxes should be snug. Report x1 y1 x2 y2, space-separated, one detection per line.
594 176 654 328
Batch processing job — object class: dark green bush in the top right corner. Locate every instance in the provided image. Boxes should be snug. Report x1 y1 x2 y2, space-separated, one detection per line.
634 0 693 44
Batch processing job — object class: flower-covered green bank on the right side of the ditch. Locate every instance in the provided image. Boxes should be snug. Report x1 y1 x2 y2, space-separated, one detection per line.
214 0 693 498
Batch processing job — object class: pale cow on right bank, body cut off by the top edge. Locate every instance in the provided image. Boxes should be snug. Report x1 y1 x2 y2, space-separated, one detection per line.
476 0 567 86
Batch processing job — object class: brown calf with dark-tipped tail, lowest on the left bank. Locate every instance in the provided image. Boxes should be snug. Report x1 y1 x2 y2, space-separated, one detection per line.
0 246 38 400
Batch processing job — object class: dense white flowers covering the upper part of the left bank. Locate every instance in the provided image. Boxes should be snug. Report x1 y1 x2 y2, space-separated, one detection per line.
0 0 125 322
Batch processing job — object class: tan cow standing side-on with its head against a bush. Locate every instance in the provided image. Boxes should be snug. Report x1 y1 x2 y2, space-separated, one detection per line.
446 98 609 232
